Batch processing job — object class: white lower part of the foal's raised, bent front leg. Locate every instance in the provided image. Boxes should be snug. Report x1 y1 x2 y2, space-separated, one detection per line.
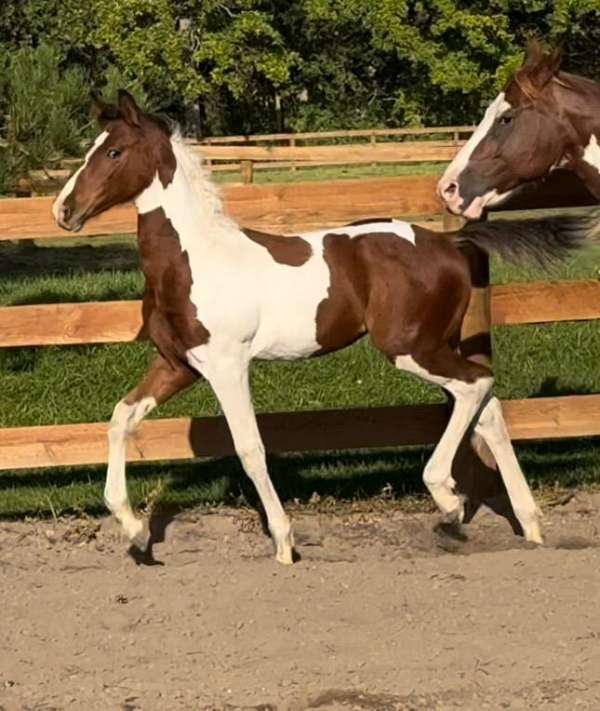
104 397 156 540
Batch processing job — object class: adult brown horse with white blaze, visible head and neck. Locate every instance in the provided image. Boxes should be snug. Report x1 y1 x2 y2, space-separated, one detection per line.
438 42 600 219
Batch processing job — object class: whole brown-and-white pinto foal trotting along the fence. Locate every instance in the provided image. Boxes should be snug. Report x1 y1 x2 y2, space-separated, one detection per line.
54 91 582 563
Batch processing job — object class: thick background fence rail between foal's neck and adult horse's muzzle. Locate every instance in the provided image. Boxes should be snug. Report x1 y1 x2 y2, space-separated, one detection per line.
194 141 457 163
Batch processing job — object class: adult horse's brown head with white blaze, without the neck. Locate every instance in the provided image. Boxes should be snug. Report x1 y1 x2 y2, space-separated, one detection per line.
438 42 577 219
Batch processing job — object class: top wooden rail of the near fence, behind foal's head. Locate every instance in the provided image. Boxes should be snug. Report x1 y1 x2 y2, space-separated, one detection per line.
0 176 441 240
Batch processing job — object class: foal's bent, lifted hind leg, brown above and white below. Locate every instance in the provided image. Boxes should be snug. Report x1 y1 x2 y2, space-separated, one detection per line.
395 346 493 521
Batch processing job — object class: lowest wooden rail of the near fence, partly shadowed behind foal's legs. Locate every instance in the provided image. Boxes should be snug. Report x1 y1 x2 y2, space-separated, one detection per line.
0 395 600 469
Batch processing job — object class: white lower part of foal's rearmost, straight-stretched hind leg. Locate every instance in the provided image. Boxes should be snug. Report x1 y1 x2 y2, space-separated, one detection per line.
475 397 542 543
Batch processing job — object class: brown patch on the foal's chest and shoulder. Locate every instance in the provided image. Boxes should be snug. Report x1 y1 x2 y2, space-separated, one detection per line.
138 207 210 366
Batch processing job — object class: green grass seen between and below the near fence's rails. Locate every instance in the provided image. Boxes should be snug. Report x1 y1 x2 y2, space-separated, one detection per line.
0 221 600 517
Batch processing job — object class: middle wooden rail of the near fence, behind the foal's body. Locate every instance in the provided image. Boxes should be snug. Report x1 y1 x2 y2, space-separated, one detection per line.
0 280 600 347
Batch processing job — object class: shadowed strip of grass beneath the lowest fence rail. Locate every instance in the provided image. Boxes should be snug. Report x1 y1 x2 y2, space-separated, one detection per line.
0 439 600 518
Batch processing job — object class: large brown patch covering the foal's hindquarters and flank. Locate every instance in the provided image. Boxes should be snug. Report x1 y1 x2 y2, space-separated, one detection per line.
316 226 483 380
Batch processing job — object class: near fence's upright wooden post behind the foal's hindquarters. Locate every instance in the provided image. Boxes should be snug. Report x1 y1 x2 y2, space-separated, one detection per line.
443 212 512 521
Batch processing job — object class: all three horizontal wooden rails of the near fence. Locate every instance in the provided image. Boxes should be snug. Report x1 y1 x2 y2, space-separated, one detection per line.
0 172 600 469
